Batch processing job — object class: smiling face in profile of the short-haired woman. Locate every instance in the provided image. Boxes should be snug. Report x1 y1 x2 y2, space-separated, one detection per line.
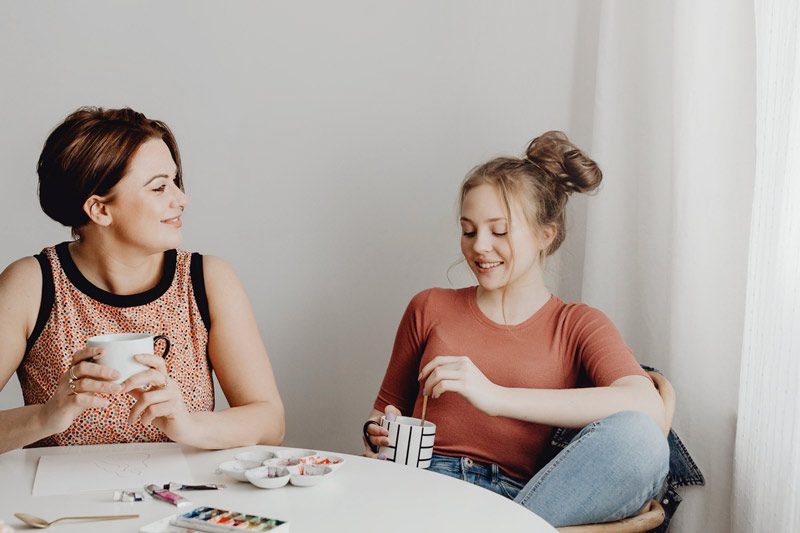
95 139 188 252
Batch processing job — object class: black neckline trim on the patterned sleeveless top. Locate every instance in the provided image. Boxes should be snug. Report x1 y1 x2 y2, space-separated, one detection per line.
56 242 178 307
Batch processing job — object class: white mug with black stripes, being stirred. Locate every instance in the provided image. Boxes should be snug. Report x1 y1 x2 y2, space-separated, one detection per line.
379 416 436 468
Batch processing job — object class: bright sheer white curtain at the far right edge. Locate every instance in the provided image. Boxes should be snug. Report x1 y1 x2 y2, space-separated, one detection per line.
733 0 800 533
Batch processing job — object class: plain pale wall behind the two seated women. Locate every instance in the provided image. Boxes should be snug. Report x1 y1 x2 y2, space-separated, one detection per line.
0 0 602 452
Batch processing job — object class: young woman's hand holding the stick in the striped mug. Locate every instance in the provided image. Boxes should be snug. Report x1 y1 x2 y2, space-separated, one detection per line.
419 355 500 416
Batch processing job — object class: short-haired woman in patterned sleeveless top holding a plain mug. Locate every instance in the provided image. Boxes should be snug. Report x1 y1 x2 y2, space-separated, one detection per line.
0 108 284 452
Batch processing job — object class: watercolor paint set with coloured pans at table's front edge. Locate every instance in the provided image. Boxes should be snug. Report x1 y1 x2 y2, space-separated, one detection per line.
139 507 289 533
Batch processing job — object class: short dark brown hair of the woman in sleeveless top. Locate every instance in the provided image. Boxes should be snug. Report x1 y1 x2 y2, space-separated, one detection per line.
36 107 183 237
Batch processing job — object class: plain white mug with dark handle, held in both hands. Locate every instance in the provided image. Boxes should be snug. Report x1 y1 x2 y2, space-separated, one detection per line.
86 333 170 383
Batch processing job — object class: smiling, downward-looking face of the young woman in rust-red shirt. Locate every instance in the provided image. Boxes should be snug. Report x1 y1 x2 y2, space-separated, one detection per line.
461 184 552 291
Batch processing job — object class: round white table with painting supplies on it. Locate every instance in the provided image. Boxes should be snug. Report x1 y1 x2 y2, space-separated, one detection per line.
0 444 556 533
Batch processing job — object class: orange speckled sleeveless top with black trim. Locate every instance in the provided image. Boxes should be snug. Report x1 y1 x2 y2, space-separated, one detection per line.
17 242 214 446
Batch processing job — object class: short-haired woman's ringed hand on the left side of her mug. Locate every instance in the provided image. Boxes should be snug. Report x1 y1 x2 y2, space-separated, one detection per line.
44 348 123 435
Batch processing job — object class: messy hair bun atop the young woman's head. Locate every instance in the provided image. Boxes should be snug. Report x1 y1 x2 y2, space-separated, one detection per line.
525 131 603 194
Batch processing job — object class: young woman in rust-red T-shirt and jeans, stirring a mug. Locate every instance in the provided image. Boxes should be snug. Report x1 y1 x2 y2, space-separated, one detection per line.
364 131 669 527
